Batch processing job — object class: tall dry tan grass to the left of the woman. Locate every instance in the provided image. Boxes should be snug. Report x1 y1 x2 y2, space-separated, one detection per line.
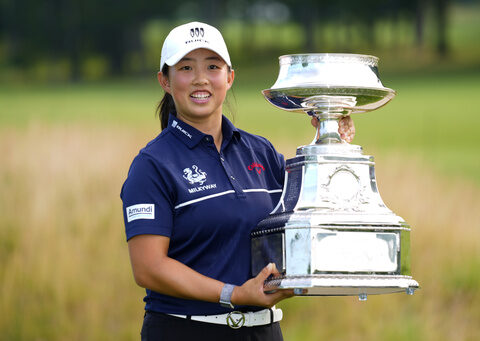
0 125 152 340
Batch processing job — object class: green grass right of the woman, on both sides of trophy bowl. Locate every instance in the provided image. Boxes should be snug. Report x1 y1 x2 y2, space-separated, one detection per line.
237 72 480 186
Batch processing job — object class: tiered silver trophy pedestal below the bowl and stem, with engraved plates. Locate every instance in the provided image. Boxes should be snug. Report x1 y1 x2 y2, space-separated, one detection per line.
251 127 418 300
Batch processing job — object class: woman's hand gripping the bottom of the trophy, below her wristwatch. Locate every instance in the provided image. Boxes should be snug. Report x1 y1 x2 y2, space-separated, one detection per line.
231 263 293 308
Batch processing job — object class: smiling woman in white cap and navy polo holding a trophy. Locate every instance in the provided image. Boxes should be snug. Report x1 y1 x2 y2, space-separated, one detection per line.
121 22 352 341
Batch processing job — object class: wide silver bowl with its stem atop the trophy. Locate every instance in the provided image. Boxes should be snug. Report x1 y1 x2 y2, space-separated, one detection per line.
262 53 396 143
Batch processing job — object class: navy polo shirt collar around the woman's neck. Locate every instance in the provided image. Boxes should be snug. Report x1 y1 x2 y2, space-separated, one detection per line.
167 115 241 149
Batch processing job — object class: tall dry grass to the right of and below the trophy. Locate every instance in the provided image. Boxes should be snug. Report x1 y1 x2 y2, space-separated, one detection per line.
282 154 480 341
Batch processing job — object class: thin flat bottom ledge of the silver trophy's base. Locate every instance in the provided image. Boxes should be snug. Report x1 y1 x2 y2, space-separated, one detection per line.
264 274 419 299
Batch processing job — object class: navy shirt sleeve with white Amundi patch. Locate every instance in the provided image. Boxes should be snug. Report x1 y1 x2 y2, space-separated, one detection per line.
120 154 173 240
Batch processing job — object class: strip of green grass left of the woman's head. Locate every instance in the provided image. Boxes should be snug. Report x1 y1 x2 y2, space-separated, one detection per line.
0 78 160 126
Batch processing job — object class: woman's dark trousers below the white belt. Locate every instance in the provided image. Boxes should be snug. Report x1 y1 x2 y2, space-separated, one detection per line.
141 311 283 341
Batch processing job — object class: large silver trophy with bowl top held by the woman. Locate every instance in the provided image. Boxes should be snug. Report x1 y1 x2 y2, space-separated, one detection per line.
251 54 418 300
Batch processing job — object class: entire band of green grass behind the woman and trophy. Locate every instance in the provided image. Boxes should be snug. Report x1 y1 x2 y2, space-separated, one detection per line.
0 68 480 183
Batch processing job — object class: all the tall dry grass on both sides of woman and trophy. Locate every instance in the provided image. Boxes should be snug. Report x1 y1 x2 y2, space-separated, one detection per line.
0 124 480 340
